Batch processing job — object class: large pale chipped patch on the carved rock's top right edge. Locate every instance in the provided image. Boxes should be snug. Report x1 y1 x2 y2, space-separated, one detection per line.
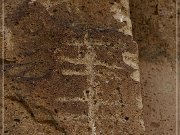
110 1 132 36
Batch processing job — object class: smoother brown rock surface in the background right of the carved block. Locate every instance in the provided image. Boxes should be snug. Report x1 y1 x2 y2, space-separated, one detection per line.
130 0 176 135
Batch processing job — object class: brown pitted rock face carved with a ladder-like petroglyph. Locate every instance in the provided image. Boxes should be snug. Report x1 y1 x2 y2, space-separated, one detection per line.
4 0 144 135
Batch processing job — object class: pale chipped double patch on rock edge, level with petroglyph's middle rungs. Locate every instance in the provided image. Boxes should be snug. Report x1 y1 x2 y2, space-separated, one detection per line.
122 52 140 82
